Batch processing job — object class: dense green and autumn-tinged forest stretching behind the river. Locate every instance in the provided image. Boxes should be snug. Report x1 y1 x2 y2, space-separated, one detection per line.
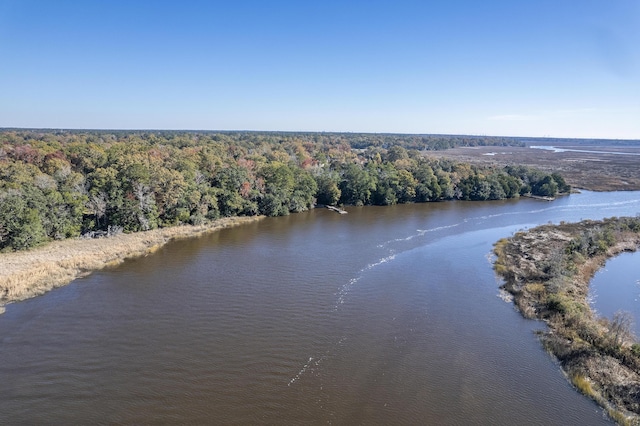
0 130 569 251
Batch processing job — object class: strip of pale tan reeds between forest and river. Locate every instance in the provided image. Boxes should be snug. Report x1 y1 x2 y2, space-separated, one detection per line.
0 216 261 313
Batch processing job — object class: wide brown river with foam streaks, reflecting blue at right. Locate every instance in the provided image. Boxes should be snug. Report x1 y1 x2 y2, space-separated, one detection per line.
0 192 640 425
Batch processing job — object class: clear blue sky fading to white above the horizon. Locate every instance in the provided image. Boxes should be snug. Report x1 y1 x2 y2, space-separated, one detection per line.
0 0 640 139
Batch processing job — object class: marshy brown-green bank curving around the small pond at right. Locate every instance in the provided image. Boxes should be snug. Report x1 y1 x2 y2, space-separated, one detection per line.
494 218 640 424
